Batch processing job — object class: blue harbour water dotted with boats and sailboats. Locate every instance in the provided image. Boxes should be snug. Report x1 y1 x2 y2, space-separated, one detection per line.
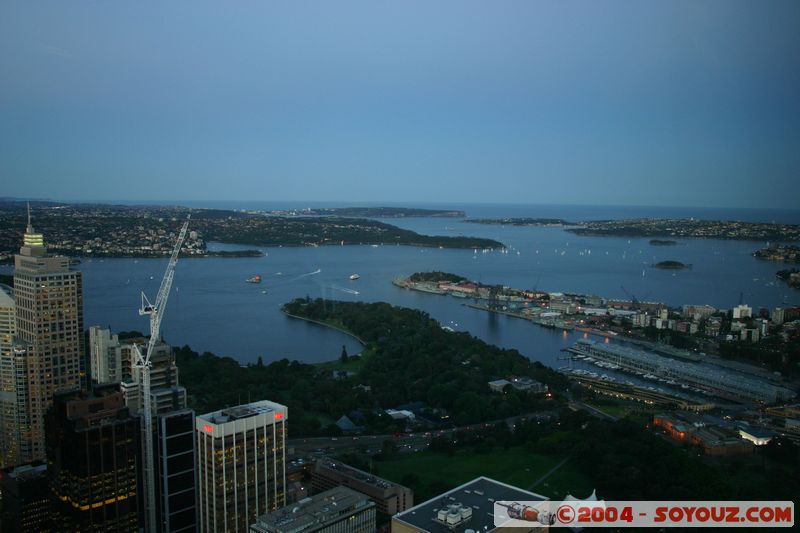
3 203 800 366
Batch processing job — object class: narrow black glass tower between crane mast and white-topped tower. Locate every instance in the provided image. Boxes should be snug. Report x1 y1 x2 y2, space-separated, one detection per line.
154 409 197 533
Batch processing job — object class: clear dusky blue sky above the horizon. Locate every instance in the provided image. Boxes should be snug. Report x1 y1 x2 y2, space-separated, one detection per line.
0 0 800 208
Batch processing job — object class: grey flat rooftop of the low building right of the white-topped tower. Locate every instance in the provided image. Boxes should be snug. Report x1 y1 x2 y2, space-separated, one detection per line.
251 487 375 532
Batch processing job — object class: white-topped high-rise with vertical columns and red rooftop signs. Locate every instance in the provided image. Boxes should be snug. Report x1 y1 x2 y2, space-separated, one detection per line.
195 400 288 532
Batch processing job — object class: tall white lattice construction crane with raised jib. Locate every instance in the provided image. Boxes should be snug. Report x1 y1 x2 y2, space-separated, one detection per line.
133 216 189 533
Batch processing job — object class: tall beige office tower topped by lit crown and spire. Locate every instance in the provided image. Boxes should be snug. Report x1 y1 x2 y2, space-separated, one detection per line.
14 210 86 460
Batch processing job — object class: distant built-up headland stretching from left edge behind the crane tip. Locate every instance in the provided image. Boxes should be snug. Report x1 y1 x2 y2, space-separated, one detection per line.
0 201 503 261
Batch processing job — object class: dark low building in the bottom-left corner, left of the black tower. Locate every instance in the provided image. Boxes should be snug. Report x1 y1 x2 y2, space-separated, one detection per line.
0 463 54 533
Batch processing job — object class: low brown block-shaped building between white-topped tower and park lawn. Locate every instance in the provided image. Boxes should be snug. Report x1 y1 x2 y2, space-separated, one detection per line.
311 459 414 516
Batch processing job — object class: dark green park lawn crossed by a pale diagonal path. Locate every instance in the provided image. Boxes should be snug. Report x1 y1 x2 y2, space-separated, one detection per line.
375 447 591 502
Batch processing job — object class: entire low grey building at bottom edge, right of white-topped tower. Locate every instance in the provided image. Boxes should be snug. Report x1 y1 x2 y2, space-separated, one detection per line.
250 487 376 533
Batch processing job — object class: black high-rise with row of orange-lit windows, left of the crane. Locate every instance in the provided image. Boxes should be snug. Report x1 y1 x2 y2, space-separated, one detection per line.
47 384 140 532
